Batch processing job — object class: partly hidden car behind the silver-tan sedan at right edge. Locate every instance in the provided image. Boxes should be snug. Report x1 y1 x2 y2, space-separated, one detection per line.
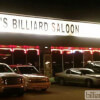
84 61 100 73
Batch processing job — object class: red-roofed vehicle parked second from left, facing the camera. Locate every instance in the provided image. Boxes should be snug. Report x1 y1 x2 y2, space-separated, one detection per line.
10 65 50 91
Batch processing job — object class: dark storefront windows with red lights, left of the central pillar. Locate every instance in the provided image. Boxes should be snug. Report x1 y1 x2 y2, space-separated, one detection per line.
0 46 39 69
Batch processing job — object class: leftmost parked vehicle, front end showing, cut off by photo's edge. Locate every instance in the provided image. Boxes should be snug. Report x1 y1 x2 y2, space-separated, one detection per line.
0 63 25 96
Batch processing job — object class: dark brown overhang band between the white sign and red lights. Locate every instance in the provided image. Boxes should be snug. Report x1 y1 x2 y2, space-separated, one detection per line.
0 33 100 48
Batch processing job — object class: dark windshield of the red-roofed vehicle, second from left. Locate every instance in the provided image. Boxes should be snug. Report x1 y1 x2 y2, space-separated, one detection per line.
19 67 39 74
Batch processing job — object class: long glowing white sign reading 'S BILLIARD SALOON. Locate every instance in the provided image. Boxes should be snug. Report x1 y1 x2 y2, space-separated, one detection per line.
0 14 100 38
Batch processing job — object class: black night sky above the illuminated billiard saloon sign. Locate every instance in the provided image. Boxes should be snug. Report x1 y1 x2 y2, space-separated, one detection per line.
0 0 100 22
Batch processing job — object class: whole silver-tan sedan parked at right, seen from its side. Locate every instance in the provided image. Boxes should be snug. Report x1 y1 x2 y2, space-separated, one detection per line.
55 68 100 87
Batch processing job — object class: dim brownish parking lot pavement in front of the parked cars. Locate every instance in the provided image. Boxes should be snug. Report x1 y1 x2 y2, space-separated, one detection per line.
0 84 97 100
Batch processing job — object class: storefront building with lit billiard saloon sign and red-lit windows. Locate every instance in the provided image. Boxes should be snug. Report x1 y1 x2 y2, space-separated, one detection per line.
0 13 100 76
